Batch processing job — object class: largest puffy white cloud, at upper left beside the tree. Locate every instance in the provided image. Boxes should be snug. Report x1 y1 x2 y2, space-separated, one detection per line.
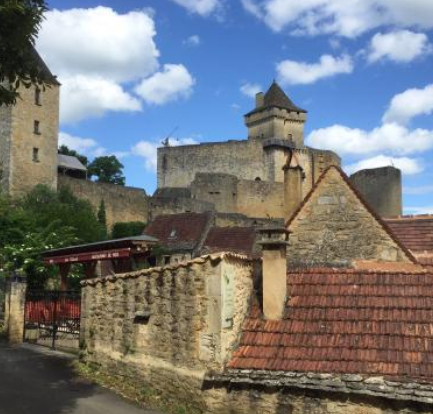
37 6 159 82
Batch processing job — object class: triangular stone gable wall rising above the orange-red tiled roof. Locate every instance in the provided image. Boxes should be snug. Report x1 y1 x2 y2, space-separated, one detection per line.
288 169 410 267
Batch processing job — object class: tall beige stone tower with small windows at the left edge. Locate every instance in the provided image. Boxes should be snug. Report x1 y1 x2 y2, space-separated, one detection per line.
0 48 60 196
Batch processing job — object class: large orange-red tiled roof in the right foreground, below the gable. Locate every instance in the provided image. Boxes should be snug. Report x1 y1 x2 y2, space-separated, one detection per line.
228 269 433 382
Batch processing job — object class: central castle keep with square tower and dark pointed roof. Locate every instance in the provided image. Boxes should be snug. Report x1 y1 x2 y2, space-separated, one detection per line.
155 82 340 222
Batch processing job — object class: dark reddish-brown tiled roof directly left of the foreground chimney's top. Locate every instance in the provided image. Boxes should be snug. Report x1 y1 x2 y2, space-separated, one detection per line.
203 227 256 255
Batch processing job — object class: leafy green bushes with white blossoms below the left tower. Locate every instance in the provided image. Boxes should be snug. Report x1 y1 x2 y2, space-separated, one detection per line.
0 185 105 287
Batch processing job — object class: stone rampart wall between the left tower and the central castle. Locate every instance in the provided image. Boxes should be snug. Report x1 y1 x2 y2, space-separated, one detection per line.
58 175 149 228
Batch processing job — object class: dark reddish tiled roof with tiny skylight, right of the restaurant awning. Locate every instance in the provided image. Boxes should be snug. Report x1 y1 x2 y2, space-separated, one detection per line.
146 213 212 249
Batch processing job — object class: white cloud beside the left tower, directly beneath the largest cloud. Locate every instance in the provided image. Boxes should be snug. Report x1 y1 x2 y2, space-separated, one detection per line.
60 75 141 123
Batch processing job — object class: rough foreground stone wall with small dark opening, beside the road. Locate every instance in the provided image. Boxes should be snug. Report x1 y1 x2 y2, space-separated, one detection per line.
81 254 253 408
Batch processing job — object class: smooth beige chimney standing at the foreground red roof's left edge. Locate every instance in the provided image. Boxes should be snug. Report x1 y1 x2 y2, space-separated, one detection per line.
258 227 289 320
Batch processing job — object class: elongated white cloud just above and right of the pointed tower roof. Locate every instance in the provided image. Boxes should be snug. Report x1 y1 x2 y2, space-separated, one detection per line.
277 55 353 85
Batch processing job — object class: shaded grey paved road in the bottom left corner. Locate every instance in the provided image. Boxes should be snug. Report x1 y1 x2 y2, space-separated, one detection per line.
0 342 162 414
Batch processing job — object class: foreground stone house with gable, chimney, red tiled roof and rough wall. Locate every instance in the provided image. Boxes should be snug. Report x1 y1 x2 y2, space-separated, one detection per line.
77 167 433 414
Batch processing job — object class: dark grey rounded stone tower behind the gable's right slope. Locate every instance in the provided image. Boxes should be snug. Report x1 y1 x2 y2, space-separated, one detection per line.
350 167 403 217
